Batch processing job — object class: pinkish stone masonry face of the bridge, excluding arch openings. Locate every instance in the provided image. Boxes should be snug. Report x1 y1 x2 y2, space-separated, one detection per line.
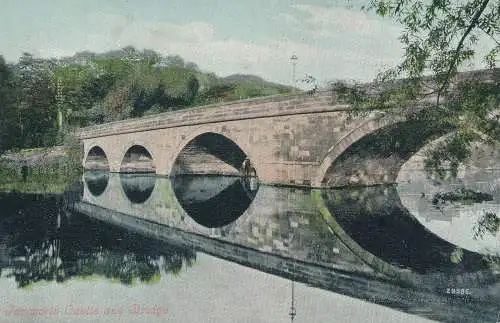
79 69 498 188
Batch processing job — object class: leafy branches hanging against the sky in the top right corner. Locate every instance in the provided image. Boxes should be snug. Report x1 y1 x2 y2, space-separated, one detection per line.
364 0 500 92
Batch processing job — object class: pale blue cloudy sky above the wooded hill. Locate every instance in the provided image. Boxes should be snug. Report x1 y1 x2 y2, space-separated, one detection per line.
0 0 496 85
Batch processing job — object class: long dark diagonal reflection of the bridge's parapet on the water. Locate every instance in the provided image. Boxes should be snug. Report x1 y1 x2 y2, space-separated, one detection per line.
74 202 498 322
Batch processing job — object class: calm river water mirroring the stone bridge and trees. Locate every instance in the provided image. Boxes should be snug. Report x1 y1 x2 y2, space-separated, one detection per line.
0 172 500 323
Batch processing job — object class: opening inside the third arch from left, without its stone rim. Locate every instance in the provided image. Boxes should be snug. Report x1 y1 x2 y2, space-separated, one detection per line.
171 132 256 175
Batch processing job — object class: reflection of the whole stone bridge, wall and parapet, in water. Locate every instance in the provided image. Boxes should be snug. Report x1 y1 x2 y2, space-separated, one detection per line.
73 174 500 321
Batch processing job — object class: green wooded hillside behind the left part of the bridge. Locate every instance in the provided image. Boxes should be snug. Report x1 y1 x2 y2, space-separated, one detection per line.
0 46 289 153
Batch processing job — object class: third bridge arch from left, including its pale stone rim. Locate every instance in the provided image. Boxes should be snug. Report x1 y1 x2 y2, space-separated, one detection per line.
170 129 258 176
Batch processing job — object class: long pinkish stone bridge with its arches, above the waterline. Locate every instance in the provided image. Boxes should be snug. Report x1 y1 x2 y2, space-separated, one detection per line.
79 71 498 188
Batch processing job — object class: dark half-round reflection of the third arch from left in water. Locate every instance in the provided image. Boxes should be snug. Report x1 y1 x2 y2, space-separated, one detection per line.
172 176 257 228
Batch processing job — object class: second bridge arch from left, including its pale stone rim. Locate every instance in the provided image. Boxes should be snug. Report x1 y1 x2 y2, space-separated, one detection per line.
118 140 156 173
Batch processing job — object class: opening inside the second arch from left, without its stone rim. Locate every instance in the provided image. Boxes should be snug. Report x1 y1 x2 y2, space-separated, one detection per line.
120 144 156 173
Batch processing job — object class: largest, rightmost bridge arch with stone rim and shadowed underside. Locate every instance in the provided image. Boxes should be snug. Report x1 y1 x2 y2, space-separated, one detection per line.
314 114 453 187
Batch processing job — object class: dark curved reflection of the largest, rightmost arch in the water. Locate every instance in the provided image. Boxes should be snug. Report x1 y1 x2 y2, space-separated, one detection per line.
311 187 494 289
